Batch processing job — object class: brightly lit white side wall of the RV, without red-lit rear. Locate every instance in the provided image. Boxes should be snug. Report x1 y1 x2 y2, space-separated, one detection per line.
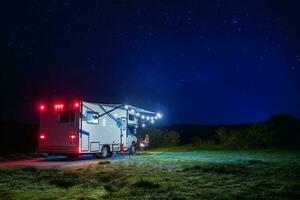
79 102 137 153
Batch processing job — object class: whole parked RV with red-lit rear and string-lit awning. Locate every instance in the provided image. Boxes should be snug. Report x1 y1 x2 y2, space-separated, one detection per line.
38 101 161 157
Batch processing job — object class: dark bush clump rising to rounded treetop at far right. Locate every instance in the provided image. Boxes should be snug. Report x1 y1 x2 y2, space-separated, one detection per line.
215 114 300 148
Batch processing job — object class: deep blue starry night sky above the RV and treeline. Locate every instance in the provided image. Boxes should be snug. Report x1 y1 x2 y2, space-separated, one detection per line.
0 0 300 124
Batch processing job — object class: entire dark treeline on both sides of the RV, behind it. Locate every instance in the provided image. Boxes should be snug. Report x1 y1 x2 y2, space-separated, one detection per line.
0 114 300 154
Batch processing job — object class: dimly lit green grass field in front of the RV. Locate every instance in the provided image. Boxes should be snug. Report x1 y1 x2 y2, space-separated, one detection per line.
0 147 300 200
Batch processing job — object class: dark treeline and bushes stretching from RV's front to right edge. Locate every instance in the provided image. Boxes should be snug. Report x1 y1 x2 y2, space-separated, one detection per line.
140 114 300 148
